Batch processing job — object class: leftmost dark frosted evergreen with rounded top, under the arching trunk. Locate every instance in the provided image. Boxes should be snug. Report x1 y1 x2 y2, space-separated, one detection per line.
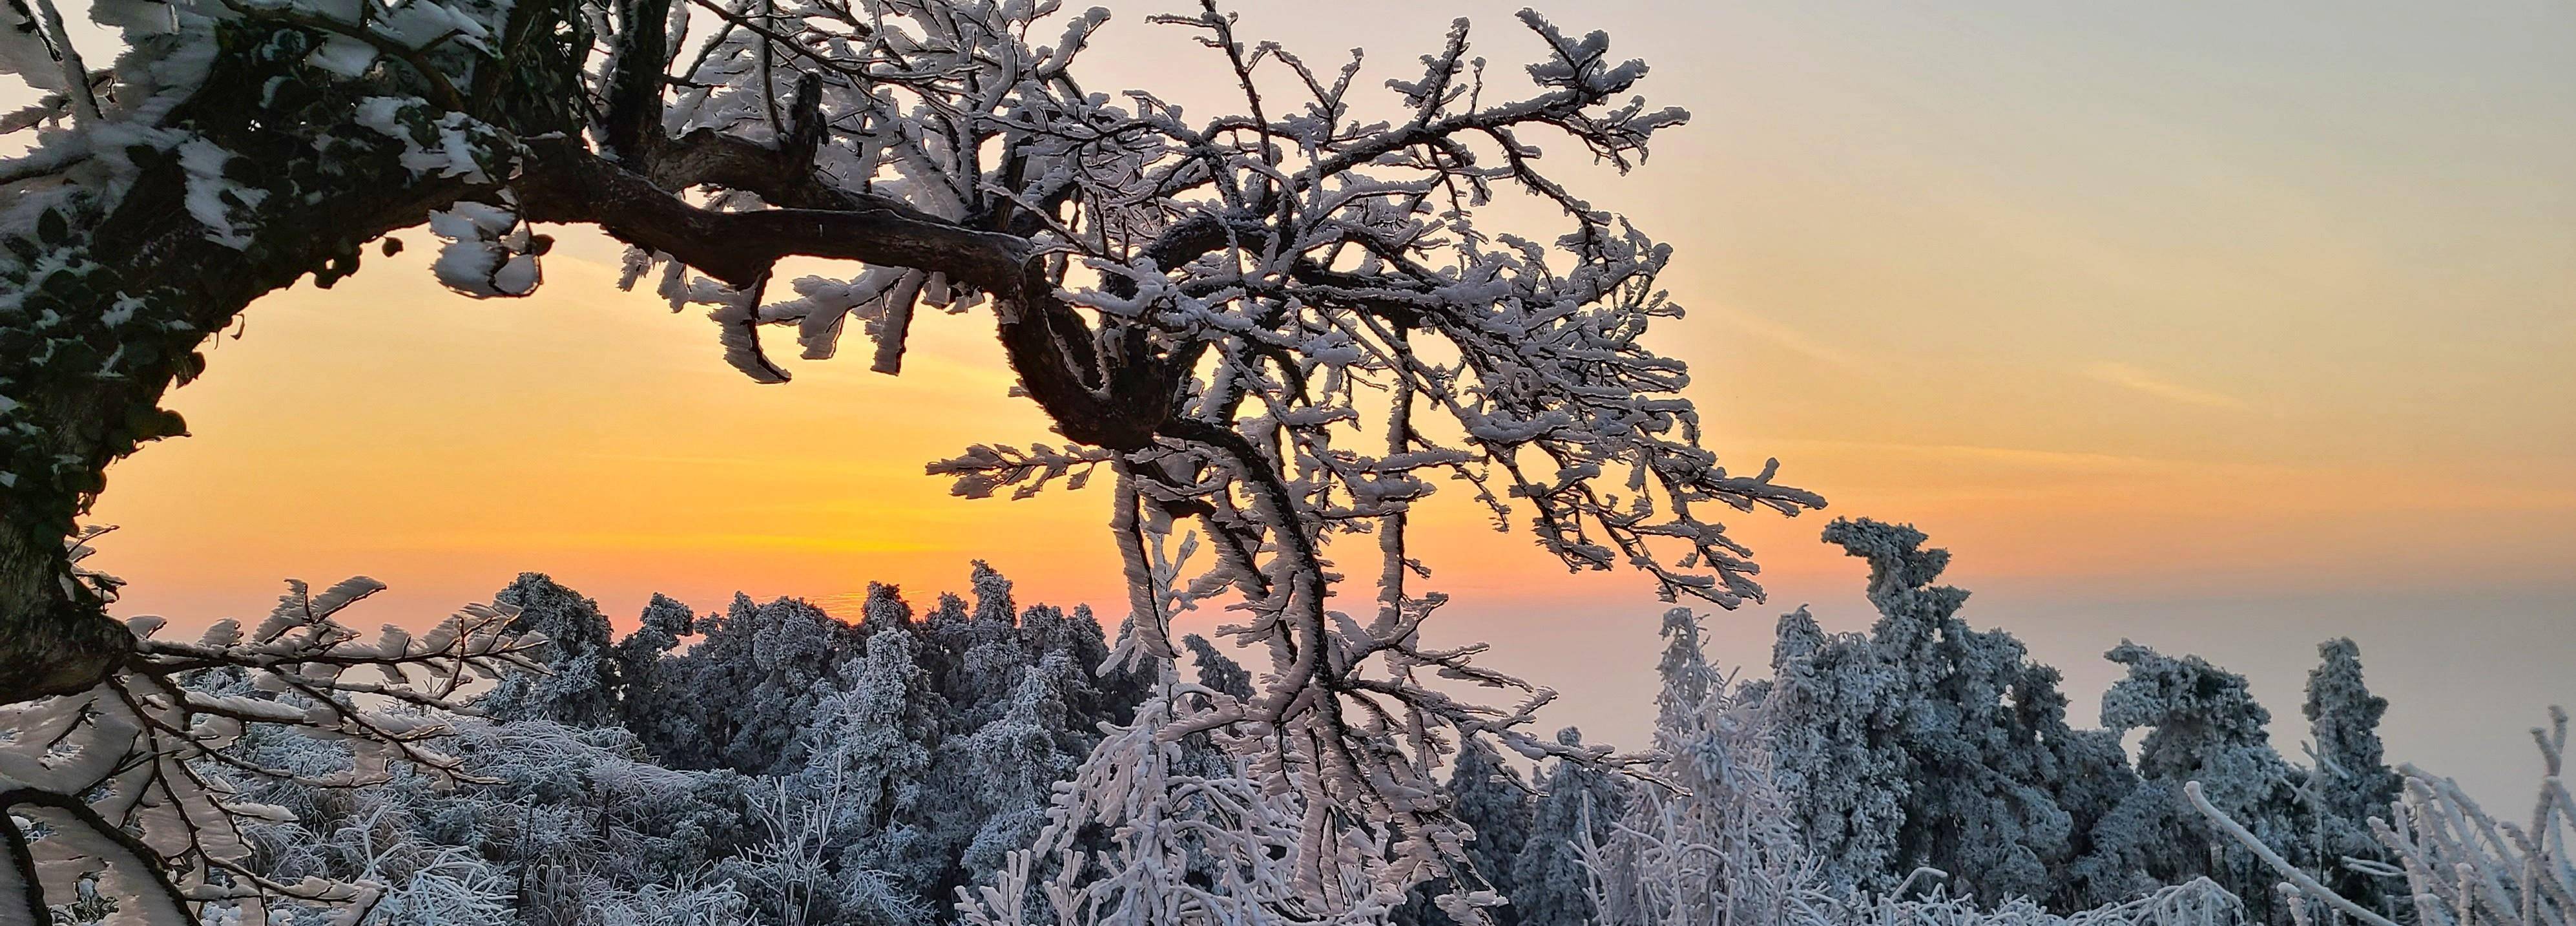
482 573 621 728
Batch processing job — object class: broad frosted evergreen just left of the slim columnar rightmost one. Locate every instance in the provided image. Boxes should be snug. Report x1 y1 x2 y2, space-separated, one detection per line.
2079 640 2313 913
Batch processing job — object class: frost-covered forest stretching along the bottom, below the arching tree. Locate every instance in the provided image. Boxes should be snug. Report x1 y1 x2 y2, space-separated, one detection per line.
25 521 2568 926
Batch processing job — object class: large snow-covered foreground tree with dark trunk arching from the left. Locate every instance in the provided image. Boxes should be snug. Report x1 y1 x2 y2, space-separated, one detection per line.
0 0 1822 913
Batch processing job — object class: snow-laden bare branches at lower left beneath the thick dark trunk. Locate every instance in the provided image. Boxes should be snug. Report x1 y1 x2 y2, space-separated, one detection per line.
0 575 543 923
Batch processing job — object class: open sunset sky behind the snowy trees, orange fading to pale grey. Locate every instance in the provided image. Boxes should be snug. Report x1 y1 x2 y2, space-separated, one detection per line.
60 3 2576 799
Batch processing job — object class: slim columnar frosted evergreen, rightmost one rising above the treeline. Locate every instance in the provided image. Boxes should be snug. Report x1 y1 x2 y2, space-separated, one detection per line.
2303 637 2406 908
